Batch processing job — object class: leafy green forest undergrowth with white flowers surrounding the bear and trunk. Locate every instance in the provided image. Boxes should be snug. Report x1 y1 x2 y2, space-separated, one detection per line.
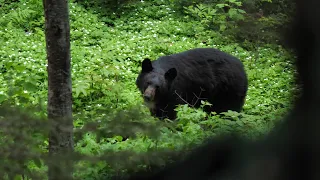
0 0 299 179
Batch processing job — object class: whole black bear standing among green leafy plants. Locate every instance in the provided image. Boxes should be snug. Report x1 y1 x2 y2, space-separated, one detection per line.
136 48 248 120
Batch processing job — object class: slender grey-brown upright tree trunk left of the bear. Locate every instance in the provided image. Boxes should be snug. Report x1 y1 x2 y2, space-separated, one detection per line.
43 0 73 180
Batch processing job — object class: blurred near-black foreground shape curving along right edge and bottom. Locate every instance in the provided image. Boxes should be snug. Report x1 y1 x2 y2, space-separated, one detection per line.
120 0 320 180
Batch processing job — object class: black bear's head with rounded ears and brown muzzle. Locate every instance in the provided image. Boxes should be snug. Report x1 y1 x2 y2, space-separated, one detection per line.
136 58 177 109
